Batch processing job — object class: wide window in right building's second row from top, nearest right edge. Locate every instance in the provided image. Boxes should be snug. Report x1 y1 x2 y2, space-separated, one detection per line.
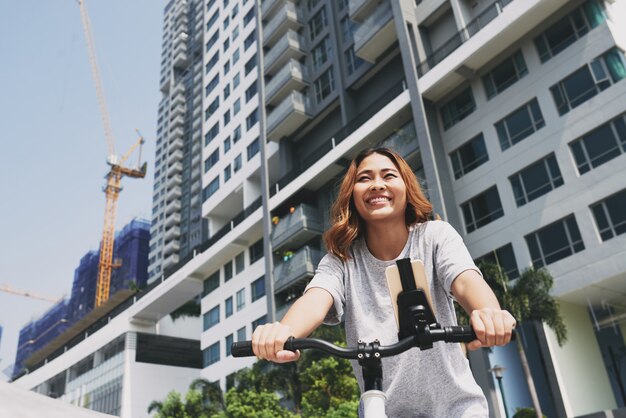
550 48 626 115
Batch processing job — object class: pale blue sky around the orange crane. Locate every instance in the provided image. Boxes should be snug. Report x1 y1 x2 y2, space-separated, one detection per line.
0 0 166 372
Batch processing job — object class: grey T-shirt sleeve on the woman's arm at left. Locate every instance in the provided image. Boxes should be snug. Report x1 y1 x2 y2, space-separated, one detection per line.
304 254 346 325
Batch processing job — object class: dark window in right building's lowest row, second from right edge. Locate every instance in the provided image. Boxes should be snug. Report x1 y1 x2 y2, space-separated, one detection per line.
524 214 585 268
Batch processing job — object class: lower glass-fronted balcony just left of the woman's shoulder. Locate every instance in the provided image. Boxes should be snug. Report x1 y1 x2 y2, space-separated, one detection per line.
274 245 322 293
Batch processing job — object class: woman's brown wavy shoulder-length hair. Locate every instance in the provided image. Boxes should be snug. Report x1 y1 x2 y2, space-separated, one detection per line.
324 148 433 261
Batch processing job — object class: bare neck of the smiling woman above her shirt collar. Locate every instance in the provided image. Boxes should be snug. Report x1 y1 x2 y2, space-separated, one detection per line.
365 220 409 261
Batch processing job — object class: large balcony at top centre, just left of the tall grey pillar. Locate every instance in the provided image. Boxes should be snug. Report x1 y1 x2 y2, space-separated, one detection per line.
354 1 397 63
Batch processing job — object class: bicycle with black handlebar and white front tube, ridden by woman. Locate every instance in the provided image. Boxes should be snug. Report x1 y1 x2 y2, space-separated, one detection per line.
231 259 510 418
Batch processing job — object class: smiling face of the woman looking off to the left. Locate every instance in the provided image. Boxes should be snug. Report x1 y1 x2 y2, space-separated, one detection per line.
352 153 406 222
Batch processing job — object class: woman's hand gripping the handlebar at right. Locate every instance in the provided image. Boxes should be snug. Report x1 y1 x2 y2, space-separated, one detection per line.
467 308 516 350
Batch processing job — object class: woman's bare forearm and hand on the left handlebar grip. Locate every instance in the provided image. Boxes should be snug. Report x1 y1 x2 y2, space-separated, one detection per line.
252 287 333 363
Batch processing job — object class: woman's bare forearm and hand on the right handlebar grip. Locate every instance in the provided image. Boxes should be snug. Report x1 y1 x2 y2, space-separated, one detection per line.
451 270 515 350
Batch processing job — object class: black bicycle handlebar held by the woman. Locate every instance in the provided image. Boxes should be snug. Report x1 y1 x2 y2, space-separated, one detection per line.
231 325 476 360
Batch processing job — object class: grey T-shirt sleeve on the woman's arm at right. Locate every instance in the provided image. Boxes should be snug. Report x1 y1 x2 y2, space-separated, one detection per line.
431 221 482 297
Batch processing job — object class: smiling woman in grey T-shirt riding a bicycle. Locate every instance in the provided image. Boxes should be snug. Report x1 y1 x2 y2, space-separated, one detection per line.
252 148 515 418
